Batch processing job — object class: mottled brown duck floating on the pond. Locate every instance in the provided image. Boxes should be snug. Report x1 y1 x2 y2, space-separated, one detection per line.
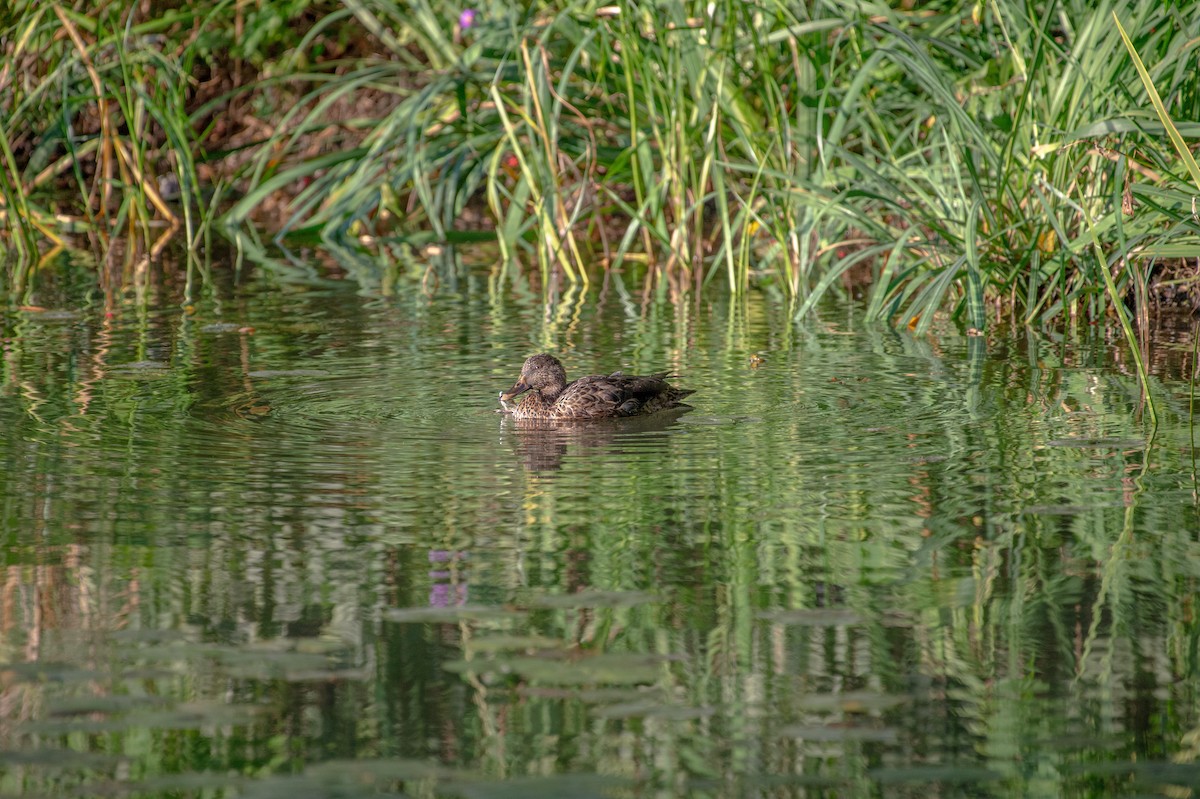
500 353 695 419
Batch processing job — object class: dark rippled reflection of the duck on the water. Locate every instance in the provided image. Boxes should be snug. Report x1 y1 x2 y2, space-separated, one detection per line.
500 405 692 471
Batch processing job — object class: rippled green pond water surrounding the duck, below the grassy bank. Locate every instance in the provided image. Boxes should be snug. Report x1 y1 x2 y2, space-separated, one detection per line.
0 257 1200 799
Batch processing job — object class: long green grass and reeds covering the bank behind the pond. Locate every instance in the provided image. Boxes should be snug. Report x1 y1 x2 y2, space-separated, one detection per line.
0 0 1200 331
